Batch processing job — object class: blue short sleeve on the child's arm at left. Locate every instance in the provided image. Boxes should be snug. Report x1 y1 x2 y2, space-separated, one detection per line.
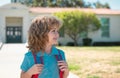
20 54 29 72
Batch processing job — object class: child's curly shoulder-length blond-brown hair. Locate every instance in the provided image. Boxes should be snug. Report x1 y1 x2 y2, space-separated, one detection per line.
27 16 61 53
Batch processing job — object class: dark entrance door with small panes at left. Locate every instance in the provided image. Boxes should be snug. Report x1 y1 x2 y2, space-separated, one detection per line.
6 26 22 43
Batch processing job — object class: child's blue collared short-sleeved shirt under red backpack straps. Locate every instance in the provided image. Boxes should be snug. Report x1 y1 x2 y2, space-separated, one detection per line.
21 46 65 78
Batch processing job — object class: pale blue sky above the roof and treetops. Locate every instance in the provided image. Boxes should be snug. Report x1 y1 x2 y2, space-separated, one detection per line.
0 0 120 10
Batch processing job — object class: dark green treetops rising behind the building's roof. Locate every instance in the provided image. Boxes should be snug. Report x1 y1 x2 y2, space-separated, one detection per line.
21 0 110 9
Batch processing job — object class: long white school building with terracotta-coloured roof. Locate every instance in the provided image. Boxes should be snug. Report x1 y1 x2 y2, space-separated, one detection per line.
0 3 120 45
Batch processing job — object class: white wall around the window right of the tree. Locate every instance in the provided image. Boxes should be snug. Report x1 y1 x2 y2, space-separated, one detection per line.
89 15 120 42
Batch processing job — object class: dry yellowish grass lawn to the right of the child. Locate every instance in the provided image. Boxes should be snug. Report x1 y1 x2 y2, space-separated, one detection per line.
58 46 120 78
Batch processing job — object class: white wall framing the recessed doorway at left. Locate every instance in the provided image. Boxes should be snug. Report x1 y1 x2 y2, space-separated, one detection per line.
0 5 30 43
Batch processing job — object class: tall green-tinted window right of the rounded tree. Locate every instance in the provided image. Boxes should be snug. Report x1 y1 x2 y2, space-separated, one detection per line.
101 18 110 38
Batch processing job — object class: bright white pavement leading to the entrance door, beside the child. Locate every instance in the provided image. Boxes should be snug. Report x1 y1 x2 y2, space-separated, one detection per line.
0 44 79 78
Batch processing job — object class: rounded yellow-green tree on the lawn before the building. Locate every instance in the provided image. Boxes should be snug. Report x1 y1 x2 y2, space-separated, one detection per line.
54 10 101 45
